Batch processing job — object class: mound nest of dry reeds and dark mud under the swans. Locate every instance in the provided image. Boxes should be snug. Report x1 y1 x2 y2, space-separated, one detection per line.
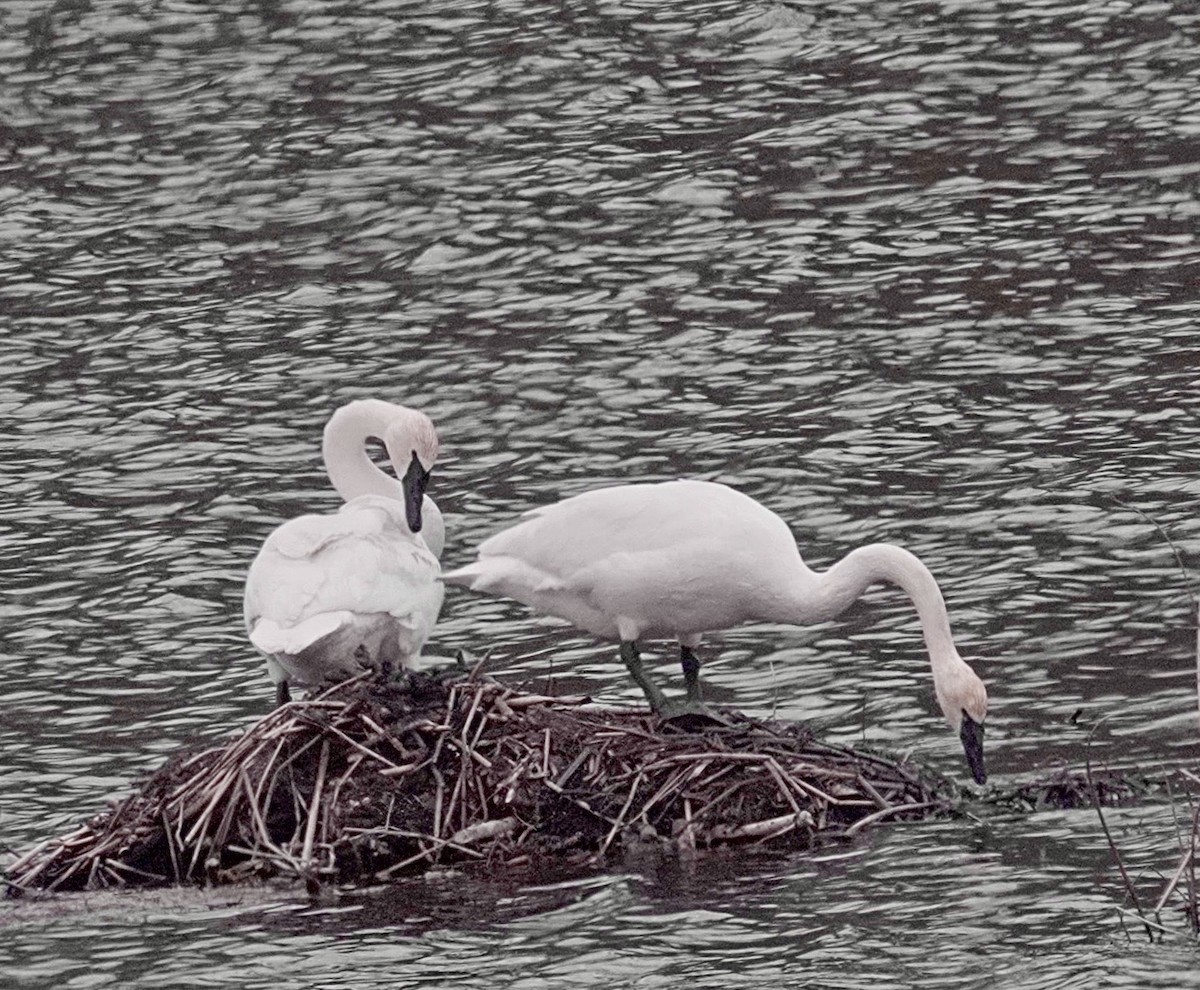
6 673 953 892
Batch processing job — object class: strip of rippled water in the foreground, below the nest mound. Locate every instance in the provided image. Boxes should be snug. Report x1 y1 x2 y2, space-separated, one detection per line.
0 811 1184 988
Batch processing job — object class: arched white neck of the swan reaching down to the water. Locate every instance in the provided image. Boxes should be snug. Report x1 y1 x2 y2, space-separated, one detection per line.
796 544 958 668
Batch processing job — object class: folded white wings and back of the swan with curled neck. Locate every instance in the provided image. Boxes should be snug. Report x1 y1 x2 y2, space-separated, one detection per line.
245 496 443 640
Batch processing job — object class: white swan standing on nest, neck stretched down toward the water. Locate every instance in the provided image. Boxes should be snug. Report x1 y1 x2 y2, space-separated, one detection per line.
442 481 988 784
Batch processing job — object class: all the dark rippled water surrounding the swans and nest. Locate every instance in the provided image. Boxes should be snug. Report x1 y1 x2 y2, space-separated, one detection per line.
0 0 1200 988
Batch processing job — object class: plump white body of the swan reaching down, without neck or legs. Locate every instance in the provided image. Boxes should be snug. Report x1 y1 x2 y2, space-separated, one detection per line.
444 481 799 637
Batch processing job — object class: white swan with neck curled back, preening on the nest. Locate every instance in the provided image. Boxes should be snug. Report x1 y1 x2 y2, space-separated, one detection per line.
245 398 445 704
